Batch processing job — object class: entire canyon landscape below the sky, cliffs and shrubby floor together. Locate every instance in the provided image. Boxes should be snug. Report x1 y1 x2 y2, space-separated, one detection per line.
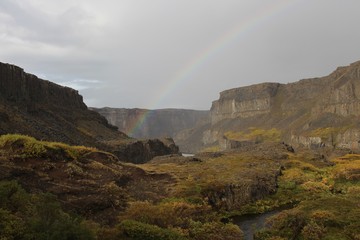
0 62 360 240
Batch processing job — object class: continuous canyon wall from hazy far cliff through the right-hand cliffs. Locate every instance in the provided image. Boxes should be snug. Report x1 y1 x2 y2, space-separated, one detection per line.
93 62 360 153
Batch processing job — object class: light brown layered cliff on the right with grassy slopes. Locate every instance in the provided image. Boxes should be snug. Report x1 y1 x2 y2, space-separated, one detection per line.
186 61 360 150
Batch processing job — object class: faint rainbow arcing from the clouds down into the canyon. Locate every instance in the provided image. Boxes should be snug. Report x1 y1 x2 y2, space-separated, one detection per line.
128 0 300 136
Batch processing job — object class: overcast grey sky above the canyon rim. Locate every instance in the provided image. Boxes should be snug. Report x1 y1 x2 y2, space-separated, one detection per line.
0 0 360 110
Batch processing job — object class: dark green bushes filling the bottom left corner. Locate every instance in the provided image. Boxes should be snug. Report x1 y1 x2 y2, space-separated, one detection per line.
0 181 95 240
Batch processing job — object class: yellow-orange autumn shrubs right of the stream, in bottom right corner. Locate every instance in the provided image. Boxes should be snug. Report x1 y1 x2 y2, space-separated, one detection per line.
236 154 360 240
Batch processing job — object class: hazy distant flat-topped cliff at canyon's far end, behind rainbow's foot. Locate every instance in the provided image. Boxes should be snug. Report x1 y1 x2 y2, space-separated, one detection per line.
91 107 209 152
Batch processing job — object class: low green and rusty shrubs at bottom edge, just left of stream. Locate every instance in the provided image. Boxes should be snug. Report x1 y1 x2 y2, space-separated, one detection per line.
120 199 242 240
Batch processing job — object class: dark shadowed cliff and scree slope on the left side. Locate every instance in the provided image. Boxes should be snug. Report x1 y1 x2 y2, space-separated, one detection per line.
0 63 178 162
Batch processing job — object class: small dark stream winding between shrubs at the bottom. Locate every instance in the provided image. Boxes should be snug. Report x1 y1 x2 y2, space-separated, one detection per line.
233 208 285 240
